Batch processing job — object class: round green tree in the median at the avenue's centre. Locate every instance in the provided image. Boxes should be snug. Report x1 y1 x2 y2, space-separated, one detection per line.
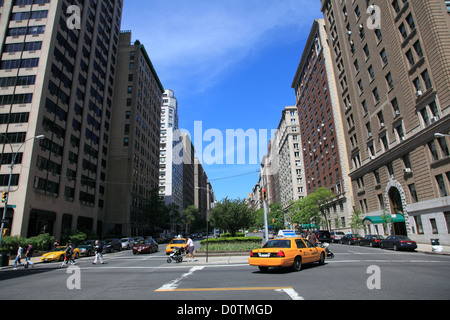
210 197 255 237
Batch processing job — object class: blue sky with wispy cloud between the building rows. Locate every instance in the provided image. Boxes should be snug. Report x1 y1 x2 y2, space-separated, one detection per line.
121 0 323 200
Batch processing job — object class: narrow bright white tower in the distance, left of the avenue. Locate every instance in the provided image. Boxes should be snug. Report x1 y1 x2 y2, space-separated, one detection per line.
159 89 183 209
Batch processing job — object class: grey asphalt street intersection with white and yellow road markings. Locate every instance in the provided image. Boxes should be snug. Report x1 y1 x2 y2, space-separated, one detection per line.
0 244 450 301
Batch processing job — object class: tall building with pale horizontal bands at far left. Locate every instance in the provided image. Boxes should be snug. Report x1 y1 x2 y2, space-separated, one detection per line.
0 0 122 238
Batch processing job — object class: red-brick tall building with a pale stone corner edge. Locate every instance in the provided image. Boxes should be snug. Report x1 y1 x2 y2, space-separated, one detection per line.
292 19 353 230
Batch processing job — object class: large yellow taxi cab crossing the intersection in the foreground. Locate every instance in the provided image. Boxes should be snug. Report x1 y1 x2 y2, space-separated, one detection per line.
248 237 327 272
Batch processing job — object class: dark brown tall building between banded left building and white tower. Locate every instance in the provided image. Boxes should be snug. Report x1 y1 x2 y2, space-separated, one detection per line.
105 31 164 236
